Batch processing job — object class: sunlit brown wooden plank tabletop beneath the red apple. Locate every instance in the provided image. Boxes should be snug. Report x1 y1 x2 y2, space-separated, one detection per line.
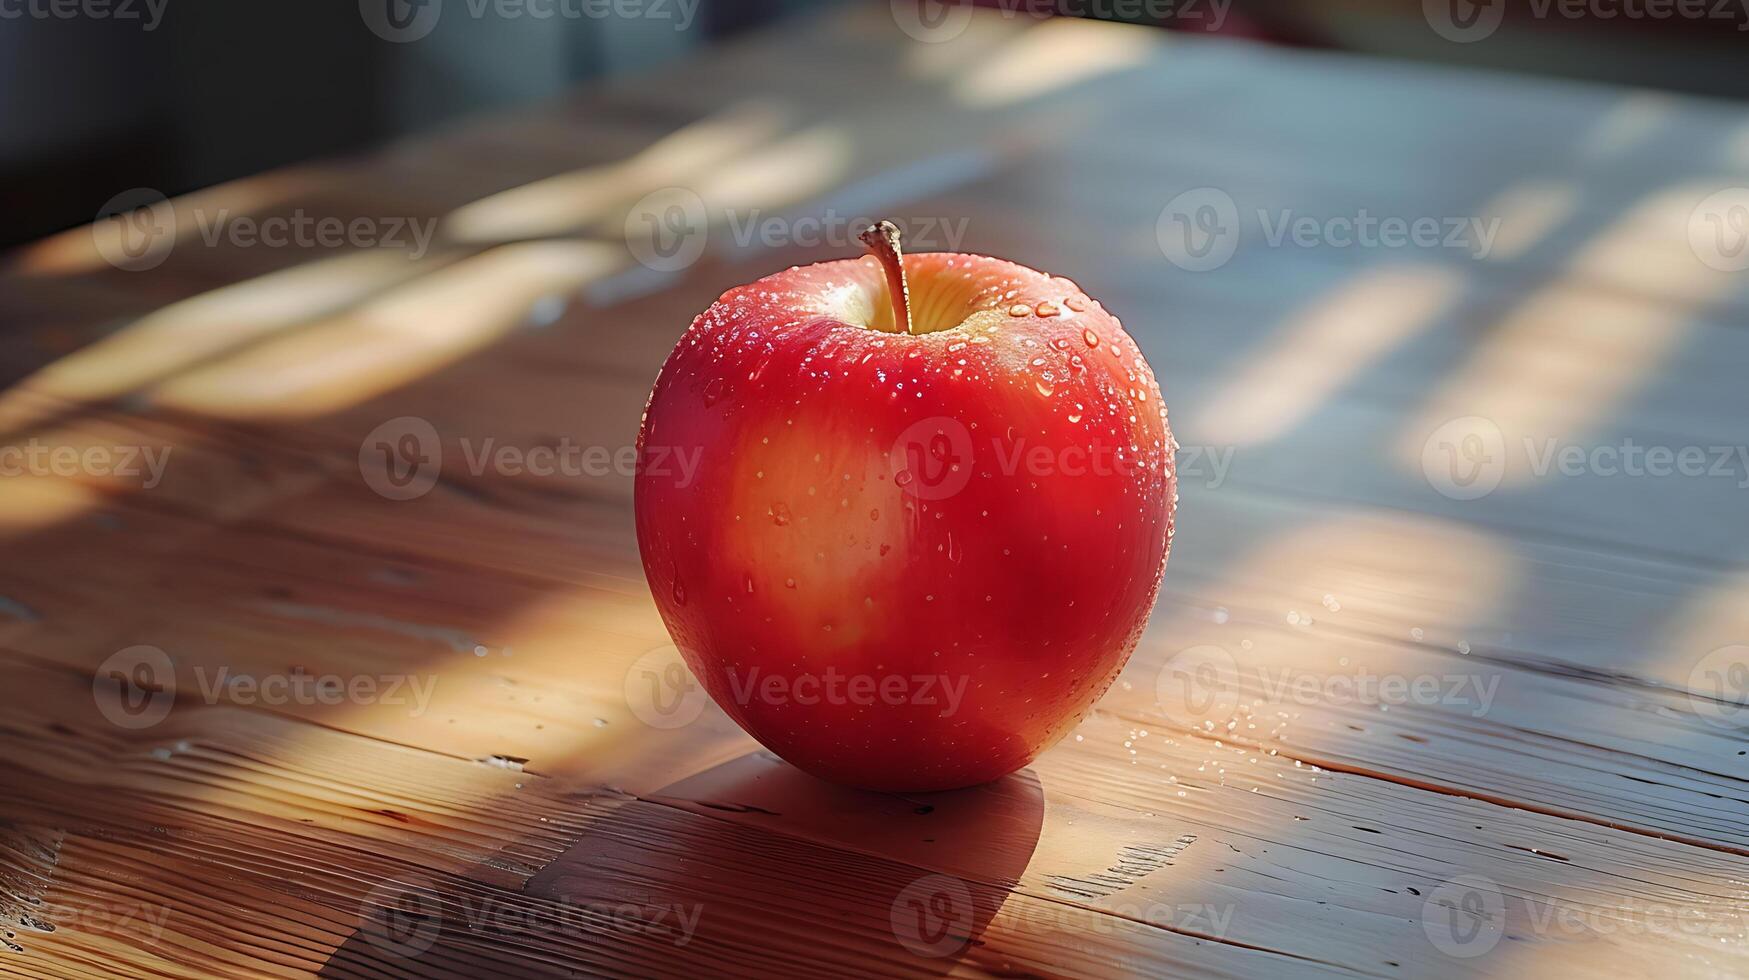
0 4 1749 978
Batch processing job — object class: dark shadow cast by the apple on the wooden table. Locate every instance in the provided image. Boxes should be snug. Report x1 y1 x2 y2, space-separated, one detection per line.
318 751 1044 978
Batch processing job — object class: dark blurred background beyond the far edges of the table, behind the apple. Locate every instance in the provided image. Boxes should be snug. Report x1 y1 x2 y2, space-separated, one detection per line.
10 0 1749 247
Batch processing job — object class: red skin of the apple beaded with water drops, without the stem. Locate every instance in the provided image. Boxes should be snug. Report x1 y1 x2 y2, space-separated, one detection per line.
635 252 1177 791
